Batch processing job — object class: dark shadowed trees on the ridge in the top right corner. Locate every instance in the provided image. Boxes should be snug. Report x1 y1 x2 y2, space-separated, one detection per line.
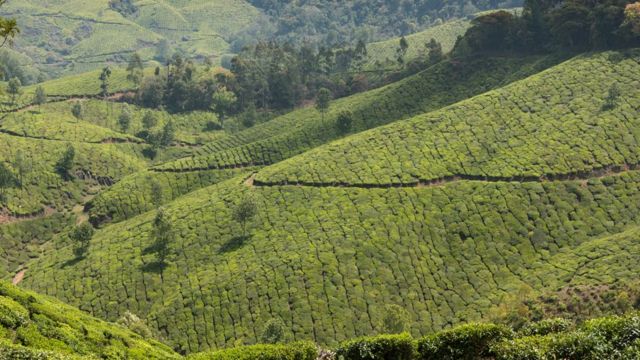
453 0 640 55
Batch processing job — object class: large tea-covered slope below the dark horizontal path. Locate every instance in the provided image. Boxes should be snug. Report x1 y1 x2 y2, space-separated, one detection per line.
25 166 640 351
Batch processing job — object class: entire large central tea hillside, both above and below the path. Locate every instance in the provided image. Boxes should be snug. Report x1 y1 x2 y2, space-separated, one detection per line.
16 47 640 352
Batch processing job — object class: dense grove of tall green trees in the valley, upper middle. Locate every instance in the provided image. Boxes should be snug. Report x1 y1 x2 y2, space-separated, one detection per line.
128 38 443 120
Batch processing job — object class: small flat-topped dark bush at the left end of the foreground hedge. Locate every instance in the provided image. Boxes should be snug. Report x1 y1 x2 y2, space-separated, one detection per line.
336 333 415 360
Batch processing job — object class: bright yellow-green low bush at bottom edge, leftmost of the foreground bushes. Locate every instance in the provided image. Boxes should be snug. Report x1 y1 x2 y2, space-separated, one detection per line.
189 342 318 360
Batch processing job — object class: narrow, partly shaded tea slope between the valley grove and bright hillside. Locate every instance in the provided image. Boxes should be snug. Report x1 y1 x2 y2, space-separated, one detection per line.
155 57 559 171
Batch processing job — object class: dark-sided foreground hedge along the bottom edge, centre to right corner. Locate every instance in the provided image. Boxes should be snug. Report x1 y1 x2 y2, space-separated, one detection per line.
336 314 640 360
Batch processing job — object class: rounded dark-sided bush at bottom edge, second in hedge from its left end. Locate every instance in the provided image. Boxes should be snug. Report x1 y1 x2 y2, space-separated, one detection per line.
418 324 512 360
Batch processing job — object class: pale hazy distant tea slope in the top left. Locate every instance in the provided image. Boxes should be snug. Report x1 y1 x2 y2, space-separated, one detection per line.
2 0 259 74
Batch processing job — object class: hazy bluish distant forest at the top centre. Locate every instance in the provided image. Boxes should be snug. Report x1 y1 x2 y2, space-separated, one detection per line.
238 0 522 48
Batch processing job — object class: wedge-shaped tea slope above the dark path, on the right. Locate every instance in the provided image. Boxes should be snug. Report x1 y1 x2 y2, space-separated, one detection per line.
256 51 640 186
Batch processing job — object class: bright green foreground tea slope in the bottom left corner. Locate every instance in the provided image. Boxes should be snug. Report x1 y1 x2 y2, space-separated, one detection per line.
0 282 179 360
